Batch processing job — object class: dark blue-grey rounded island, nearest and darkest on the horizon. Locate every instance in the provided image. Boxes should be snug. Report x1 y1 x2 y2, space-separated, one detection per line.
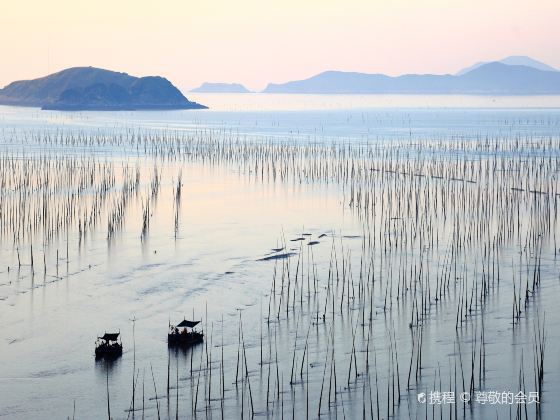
0 67 207 111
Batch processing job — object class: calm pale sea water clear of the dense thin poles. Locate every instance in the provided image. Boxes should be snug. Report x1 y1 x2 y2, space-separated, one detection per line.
0 94 560 419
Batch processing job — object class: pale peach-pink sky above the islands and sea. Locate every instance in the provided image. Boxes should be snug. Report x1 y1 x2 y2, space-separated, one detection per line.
0 0 560 91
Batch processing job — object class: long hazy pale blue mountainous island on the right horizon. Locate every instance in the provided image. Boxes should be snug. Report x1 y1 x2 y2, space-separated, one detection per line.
263 57 560 95
